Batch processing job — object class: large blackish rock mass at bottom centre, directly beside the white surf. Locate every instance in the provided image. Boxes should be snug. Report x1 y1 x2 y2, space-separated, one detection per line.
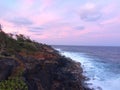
24 57 83 90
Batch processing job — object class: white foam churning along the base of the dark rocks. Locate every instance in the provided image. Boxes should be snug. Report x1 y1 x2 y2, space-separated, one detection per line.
58 51 120 90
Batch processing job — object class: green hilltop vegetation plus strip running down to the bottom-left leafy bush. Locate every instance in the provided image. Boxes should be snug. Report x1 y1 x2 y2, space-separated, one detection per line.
0 30 31 90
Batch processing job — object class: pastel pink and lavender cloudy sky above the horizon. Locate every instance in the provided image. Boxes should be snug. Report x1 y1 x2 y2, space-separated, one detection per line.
0 0 120 46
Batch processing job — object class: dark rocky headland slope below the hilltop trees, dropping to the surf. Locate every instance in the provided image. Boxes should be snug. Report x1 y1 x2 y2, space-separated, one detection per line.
0 29 89 90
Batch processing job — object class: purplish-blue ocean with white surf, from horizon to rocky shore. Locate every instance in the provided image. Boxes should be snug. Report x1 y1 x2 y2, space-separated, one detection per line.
53 46 120 90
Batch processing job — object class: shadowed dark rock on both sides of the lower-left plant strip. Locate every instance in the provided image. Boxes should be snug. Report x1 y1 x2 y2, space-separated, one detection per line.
0 55 84 90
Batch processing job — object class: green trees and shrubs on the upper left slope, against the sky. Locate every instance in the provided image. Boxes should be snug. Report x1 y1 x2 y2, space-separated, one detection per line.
0 28 40 54
